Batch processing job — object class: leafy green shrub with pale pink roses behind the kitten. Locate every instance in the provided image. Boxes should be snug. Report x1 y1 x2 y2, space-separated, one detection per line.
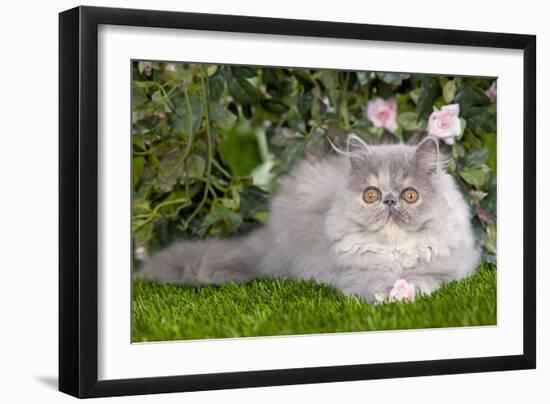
132 62 497 262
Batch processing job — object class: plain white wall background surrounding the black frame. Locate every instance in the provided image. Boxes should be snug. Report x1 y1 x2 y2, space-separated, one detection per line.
0 0 550 404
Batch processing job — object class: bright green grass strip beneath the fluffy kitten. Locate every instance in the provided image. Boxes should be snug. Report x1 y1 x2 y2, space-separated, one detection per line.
132 264 497 342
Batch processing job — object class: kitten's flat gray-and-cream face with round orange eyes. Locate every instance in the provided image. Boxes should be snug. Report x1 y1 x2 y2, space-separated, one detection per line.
346 139 439 231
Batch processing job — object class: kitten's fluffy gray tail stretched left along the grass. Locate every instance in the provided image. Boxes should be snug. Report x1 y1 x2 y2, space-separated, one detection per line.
136 228 270 285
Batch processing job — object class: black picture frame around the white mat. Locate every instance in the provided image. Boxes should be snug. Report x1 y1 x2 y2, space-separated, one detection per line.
59 7 536 398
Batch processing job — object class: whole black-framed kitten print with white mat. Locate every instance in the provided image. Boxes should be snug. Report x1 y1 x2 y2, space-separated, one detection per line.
59 7 536 397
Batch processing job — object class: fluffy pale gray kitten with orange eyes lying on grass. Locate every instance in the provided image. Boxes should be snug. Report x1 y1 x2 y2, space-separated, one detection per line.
138 135 480 302
